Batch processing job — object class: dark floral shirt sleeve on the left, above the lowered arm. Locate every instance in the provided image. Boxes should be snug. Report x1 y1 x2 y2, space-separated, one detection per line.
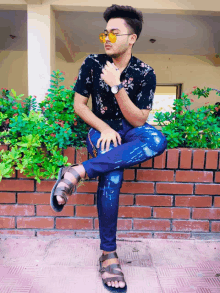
73 54 93 98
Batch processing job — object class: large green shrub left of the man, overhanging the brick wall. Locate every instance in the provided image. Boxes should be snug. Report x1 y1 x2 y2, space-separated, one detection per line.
0 71 89 182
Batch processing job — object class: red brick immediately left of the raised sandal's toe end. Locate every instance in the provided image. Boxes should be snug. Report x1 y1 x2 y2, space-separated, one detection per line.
18 192 50 204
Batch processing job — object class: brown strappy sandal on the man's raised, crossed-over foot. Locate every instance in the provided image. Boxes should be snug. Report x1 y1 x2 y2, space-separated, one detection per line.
50 164 81 212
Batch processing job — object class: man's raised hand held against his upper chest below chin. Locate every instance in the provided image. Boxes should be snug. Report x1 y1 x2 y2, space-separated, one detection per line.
100 61 121 87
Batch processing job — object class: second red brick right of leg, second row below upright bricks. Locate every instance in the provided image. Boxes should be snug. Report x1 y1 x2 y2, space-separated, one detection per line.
156 183 193 194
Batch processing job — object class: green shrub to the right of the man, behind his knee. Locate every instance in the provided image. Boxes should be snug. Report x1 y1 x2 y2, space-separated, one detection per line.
154 87 220 149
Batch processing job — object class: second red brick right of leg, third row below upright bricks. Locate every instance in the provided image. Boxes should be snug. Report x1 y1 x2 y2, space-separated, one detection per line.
136 195 173 206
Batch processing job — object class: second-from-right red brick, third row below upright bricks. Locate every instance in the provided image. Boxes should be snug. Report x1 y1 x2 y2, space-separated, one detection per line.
175 196 212 208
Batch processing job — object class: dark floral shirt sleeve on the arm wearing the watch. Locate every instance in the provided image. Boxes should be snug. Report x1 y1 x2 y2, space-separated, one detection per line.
135 69 156 110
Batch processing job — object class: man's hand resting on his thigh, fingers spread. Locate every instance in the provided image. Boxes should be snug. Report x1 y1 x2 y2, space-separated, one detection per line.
96 128 121 152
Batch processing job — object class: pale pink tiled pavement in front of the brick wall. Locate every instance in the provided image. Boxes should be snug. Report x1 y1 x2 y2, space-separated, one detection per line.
0 237 220 293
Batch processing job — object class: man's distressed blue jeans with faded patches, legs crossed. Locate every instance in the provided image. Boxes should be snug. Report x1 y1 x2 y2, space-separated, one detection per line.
82 118 167 251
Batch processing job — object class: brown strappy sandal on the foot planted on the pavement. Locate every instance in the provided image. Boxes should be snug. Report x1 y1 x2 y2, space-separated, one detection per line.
99 252 127 292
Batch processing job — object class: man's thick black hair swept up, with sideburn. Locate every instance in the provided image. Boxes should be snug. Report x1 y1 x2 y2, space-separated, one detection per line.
103 4 143 47
